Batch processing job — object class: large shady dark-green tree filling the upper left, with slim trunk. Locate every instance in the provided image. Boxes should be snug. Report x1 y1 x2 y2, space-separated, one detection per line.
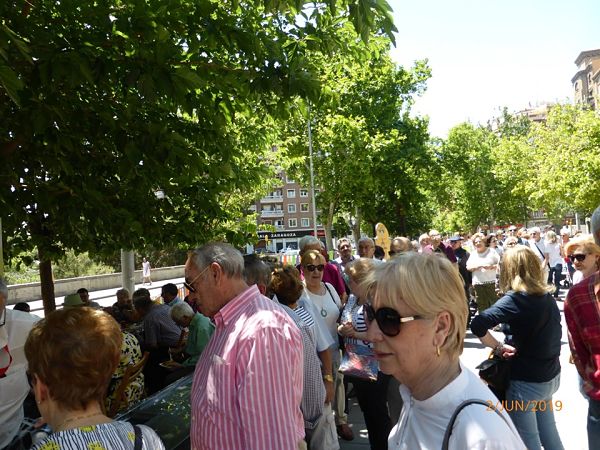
0 0 394 312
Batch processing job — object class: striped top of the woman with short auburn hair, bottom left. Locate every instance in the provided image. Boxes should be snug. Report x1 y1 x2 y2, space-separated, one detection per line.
31 422 165 450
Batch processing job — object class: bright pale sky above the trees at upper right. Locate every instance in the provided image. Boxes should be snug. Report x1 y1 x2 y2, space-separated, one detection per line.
388 0 600 137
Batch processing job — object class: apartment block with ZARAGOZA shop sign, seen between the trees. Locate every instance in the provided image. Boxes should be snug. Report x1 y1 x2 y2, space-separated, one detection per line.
252 172 325 252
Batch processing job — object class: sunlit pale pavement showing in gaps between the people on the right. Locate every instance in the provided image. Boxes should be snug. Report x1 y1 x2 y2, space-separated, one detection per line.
340 291 588 450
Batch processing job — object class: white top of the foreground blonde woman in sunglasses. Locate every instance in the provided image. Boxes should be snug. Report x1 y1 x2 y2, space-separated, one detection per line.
388 363 526 450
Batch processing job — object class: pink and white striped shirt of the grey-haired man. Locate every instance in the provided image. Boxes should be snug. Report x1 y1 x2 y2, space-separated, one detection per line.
190 286 304 450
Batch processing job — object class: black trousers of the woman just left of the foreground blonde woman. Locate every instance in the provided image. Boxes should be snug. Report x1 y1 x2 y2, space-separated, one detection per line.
349 372 392 450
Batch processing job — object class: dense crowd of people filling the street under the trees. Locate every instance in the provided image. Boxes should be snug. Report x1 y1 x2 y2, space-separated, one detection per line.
0 208 600 450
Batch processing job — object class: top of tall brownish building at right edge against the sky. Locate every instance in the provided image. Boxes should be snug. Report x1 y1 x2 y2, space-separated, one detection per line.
571 49 600 109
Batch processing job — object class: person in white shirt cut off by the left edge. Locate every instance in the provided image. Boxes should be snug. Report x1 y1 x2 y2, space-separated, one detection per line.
0 279 39 448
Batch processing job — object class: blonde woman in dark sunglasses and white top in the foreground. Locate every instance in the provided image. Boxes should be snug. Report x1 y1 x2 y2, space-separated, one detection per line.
365 253 525 450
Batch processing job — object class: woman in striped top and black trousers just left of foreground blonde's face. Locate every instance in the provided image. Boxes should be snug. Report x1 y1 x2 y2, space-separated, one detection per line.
338 258 392 450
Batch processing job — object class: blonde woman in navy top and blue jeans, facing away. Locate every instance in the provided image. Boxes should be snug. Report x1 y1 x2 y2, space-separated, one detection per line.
471 245 564 450
